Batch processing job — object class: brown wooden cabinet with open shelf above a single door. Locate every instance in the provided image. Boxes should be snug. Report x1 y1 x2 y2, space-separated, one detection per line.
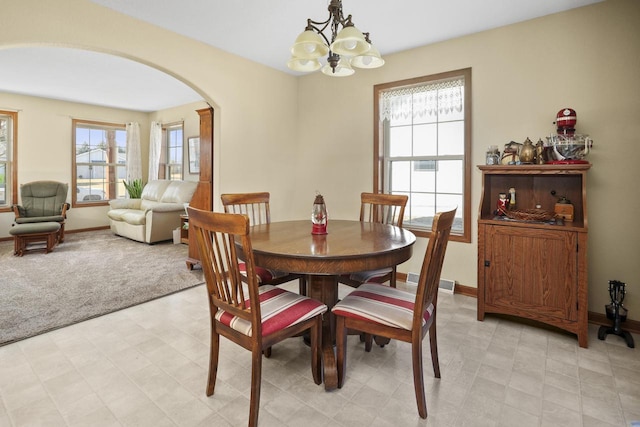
478 164 591 347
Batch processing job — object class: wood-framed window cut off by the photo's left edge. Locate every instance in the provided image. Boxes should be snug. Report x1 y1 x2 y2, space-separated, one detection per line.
0 111 18 212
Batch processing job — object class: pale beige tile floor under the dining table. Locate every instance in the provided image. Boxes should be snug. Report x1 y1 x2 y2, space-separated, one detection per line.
0 283 640 427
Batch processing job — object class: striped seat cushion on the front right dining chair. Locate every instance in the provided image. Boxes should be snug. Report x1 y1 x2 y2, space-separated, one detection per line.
331 283 433 331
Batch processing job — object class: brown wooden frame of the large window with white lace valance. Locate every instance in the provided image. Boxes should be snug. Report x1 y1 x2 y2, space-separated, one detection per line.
373 68 472 243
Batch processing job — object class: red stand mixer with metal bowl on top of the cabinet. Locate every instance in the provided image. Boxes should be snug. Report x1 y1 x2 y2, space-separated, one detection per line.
545 108 593 165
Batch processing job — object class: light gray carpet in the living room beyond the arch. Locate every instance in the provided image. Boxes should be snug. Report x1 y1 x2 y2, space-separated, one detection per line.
0 230 204 346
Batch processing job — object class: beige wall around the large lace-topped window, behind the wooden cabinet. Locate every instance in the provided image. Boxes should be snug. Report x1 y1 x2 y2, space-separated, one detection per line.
296 0 640 319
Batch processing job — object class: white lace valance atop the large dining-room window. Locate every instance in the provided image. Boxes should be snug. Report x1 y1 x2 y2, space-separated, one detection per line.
380 79 464 121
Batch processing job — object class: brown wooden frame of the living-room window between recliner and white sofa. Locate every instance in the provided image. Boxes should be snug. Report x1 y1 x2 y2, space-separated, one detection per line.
69 119 127 208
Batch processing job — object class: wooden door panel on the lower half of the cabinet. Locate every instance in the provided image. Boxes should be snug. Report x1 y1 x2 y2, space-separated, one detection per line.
485 226 577 321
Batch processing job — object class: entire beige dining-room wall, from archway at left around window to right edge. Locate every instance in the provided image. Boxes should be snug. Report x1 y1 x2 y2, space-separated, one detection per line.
0 0 640 319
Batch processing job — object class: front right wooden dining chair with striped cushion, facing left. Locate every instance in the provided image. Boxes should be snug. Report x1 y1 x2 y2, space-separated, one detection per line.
332 209 456 418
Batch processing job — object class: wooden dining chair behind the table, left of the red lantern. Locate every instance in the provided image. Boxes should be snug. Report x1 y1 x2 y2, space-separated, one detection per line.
220 192 307 295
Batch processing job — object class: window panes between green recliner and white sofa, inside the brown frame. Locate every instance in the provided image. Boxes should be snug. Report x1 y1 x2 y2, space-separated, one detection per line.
72 120 127 207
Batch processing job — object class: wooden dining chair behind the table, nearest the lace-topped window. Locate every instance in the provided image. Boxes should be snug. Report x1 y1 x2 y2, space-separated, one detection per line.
338 193 409 288
